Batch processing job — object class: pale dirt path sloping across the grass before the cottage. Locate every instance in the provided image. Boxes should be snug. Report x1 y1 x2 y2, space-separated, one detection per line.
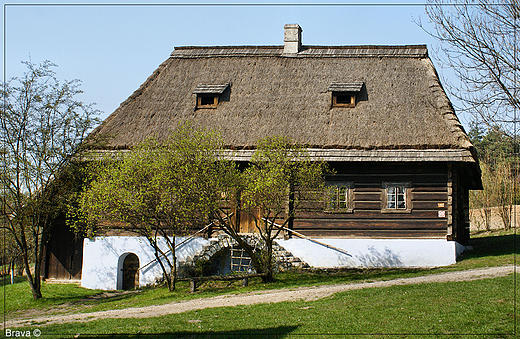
5 266 514 328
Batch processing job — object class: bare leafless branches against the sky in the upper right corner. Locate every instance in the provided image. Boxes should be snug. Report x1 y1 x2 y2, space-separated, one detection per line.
426 0 520 138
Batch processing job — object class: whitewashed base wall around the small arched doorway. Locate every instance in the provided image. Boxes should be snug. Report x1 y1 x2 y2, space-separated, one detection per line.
81 237 208 290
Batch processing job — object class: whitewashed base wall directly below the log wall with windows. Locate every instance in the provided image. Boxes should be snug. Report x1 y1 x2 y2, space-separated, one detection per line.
277 239 464 268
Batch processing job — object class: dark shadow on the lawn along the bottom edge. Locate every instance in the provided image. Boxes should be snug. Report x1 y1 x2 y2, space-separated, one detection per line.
62 326 298 339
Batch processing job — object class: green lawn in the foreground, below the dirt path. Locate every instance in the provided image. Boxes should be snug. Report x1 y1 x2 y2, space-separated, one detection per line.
23 276 514 338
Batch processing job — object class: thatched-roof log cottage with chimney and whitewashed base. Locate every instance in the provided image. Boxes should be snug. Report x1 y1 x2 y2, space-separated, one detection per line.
46 25 481 290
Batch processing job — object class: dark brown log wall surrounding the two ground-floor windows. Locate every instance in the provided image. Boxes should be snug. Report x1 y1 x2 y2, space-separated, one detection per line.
286 163 452 238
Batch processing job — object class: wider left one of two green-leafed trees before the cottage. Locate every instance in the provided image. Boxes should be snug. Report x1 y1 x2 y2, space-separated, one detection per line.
78 125 231 291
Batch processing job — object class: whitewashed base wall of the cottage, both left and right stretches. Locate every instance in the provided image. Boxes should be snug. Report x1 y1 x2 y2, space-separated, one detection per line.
81 237 464 290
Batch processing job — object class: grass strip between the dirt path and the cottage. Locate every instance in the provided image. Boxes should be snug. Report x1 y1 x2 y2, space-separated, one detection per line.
4 231 516 319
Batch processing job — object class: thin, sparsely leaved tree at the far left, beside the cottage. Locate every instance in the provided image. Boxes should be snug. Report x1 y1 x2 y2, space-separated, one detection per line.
0 61 98 299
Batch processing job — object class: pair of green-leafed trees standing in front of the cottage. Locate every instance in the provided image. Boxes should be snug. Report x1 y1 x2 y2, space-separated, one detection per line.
77 133 326 286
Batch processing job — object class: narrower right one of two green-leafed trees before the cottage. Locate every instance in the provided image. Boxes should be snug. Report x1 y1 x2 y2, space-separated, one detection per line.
214 137 326 281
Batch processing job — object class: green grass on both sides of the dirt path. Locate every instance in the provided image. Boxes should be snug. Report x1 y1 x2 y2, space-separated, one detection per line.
5 232 515 338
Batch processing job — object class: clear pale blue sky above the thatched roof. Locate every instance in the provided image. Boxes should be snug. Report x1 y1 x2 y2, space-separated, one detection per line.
2 0 466 127
